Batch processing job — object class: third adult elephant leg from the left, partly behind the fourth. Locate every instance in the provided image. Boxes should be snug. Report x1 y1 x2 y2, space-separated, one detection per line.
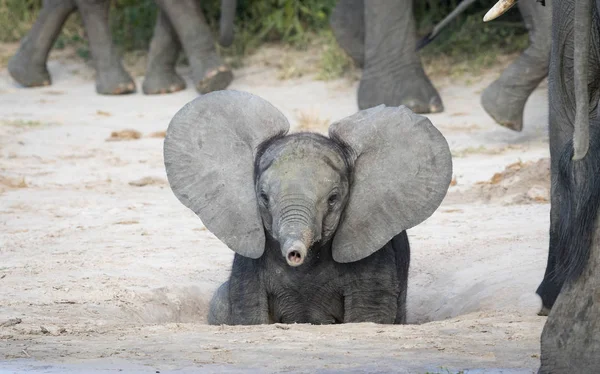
142 11 185 95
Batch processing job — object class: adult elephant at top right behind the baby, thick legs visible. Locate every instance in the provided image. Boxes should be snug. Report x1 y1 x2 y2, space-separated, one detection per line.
331 0 551 125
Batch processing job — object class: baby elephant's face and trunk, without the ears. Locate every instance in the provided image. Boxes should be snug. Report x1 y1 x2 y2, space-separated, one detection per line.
255 133 352 266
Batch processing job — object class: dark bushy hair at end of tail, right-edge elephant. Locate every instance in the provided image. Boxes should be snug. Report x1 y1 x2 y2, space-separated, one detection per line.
553 126 600 284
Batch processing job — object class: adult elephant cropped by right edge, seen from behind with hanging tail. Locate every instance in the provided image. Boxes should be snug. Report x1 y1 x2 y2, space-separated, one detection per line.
486 0 600 373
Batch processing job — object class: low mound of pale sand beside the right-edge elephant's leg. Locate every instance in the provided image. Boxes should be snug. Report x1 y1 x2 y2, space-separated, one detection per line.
446 158 550 205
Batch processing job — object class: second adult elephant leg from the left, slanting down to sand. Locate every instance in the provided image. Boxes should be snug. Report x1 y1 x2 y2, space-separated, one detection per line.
75 0 135 95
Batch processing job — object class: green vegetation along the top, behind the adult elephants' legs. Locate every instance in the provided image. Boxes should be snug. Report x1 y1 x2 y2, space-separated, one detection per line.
0 0 527 79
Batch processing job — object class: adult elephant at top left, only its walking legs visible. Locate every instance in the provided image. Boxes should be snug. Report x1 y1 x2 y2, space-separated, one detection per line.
8 0 236 95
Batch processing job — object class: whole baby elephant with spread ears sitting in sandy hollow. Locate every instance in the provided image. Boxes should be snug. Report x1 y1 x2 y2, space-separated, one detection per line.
164 90 452 325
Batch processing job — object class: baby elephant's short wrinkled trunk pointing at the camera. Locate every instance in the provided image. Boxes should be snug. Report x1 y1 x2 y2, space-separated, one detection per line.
273 200 321 266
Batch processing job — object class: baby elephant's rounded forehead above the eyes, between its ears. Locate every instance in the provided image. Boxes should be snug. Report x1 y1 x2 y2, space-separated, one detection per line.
259 134 346 172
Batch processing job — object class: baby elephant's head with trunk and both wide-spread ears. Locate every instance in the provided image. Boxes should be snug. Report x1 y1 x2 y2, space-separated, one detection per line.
164 90 452 266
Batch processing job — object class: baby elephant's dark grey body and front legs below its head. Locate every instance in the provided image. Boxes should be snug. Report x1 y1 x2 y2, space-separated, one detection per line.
208 225 410 325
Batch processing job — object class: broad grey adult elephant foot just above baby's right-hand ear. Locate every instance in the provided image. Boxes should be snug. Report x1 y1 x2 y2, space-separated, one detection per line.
358 64 444 113
